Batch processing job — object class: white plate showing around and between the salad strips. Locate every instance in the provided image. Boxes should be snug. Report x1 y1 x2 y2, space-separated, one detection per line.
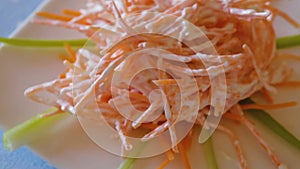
0 0 300 169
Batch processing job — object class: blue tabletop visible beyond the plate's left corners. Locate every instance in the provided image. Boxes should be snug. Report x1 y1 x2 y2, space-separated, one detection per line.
0 0 55 169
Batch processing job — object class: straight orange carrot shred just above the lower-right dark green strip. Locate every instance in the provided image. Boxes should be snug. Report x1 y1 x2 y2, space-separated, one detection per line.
241 101 297 110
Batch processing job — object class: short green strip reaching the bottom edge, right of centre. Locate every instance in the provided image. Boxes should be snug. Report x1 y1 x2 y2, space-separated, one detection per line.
203 137 218 169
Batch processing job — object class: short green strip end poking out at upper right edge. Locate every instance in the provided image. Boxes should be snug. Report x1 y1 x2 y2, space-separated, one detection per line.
276 35 300 49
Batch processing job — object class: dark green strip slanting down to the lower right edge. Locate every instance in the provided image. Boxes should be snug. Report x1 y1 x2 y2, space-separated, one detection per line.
242 99 300 150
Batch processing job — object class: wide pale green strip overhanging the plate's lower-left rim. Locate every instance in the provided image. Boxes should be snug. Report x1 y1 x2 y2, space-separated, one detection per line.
3 108 70 151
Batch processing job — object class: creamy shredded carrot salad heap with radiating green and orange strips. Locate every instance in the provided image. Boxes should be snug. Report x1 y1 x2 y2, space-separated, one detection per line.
0 0 300 169
